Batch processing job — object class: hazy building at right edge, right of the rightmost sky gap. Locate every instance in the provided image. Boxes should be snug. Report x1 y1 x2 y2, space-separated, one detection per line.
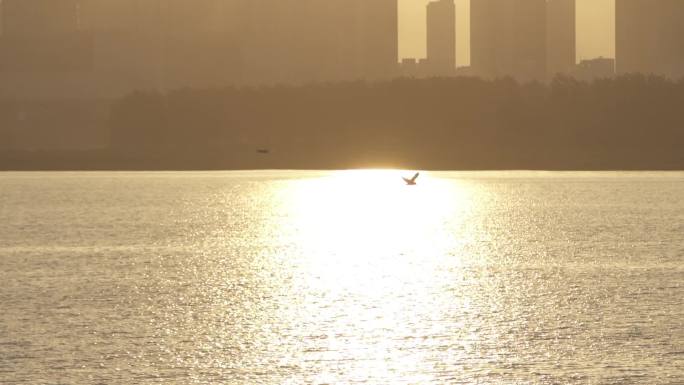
615 0 684 78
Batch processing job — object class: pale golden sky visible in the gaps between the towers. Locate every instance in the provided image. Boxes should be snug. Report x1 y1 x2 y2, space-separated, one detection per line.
399 0 615 65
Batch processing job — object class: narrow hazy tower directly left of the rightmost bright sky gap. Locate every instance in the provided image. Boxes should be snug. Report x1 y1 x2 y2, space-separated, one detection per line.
546 0 577 78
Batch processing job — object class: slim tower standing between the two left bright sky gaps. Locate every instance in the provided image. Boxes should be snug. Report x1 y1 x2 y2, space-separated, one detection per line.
427 0 456 75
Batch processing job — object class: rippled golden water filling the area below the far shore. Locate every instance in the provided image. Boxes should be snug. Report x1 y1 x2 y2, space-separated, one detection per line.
0 171 684 385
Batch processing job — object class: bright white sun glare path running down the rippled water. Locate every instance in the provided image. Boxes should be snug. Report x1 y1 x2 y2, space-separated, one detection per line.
268 170 480 383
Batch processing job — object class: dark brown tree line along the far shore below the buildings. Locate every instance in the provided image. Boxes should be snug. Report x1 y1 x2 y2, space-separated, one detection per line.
1 75 684 170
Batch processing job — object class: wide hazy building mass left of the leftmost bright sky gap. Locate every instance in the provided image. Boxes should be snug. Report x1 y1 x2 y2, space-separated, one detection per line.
0 0 399 97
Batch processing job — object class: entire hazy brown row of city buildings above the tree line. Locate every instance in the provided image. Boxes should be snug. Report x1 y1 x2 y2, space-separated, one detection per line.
0 0 684 97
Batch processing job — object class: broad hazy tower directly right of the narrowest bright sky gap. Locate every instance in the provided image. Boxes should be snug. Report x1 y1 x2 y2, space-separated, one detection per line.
470 0 547 81
